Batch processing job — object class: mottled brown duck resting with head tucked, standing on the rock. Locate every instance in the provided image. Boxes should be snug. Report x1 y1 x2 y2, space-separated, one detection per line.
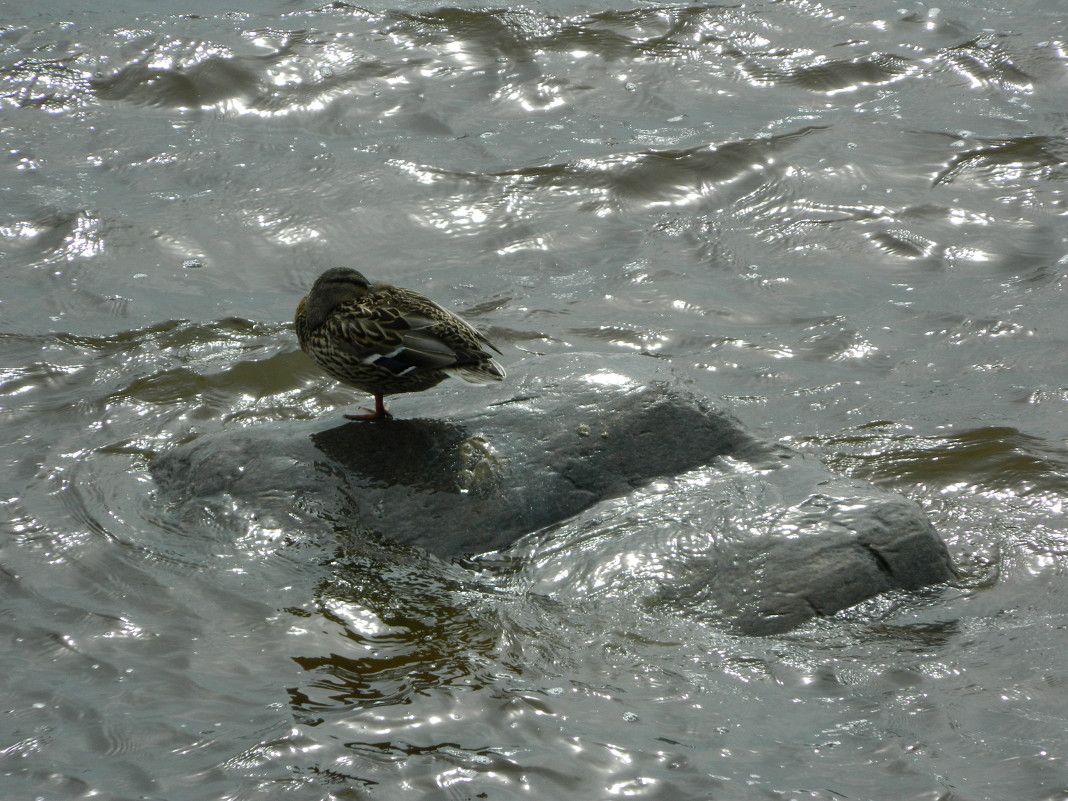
296 267 504 420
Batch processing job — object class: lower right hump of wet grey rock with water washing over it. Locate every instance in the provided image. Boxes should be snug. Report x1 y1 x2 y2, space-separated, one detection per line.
484 454 955 634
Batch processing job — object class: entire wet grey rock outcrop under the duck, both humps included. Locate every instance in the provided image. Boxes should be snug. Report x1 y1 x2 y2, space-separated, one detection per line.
152 356 954 633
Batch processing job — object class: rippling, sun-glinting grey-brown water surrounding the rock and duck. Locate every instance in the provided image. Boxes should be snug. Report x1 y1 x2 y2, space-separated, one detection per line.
0 0 1068 801
